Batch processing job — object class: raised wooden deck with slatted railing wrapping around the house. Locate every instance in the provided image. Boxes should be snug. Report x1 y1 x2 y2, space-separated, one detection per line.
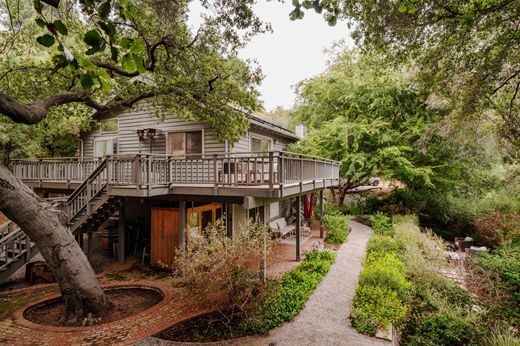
13 152 339 198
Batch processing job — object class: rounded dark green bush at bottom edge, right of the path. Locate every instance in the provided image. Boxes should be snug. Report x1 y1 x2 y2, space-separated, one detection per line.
406 315 477 346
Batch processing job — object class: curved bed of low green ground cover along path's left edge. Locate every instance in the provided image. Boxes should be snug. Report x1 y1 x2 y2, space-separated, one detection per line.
156 250 335 342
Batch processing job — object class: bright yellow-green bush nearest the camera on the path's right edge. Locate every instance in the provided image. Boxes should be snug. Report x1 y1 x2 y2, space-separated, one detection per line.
352 285 409 336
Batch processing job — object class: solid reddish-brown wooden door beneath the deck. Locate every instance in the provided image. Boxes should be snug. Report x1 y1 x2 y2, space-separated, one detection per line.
151 208 179 267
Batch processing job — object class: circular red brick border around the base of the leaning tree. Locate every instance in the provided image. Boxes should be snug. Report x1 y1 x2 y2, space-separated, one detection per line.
13 282 172 333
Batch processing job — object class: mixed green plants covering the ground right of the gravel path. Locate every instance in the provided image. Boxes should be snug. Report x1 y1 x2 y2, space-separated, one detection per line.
352 215 520 346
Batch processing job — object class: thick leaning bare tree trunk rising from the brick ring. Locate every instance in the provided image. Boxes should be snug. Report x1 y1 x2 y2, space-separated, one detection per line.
0 165 108 324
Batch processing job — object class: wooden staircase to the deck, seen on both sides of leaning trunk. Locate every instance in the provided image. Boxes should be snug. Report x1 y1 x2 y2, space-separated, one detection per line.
0 159 123 283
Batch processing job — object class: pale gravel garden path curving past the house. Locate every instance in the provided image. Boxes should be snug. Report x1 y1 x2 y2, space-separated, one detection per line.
139 221 391 346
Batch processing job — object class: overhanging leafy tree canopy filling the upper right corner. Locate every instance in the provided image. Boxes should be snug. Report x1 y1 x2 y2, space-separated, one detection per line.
291 0 520 153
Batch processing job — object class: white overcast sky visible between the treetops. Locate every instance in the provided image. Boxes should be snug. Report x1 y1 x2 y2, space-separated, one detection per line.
190 0 353 111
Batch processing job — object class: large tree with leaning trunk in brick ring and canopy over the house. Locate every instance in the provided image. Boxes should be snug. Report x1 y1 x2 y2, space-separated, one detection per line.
0 0 268 321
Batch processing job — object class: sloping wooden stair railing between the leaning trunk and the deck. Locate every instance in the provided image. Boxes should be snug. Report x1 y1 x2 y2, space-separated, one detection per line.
63 159 108 222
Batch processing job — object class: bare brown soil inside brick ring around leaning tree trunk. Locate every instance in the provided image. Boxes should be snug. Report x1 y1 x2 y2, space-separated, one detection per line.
23 287 164 326
